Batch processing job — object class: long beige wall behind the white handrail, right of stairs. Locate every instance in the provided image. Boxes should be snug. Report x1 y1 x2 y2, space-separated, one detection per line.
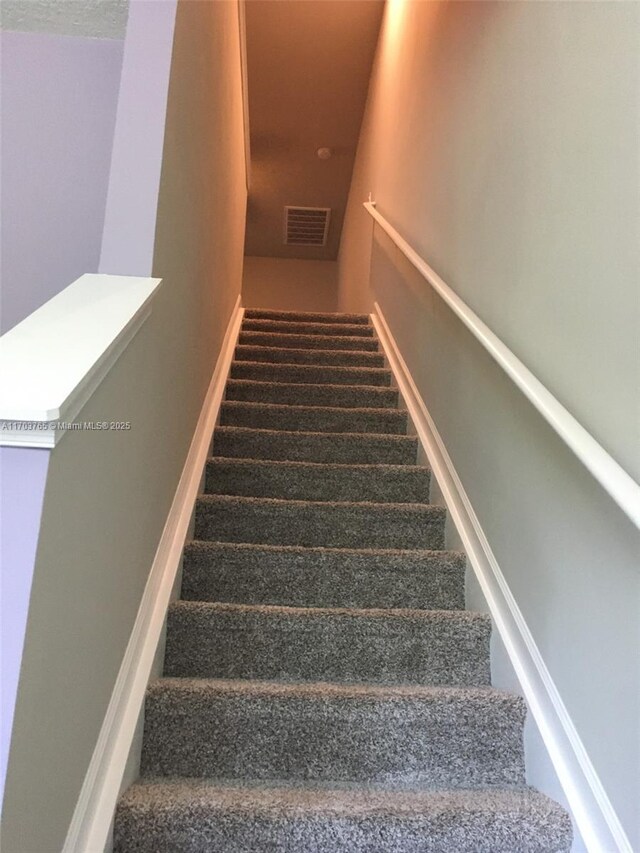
339 0 640 849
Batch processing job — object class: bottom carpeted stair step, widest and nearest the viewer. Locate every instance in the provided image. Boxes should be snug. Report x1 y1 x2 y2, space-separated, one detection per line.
114 779 572 853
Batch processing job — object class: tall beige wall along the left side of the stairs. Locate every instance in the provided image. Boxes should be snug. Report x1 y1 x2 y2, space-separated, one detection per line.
2 0 246 853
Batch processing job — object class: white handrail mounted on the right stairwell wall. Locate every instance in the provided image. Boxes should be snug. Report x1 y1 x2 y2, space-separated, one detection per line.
364 202 640 528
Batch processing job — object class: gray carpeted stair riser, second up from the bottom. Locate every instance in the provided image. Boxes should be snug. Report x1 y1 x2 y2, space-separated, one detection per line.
141 679 525 788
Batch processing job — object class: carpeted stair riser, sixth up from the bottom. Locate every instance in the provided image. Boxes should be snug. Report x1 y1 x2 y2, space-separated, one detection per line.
205 459 430 503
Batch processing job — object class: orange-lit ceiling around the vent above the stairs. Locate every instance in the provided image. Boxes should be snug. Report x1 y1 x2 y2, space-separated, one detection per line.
245 0 384 260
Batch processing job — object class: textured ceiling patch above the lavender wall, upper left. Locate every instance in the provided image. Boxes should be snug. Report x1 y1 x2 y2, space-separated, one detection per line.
0 0 129 39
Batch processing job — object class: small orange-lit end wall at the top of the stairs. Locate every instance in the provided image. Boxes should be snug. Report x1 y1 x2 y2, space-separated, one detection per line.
242 257 338 311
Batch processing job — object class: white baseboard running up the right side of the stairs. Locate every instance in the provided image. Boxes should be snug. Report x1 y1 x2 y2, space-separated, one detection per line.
371 303 633 853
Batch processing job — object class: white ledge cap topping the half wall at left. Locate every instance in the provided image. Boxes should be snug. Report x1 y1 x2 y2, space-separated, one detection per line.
0 273 162 447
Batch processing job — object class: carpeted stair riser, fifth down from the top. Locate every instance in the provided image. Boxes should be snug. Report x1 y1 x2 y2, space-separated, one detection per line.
230 361 391 387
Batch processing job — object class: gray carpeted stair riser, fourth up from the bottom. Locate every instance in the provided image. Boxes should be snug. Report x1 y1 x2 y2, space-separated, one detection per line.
182 542 465 610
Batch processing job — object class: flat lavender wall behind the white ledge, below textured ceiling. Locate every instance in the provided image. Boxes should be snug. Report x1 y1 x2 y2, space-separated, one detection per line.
0 29 123 332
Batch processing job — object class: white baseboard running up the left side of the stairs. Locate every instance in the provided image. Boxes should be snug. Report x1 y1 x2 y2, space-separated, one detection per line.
62 296 244 853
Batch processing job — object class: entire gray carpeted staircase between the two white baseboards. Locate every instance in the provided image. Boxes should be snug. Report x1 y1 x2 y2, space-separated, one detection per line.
115 311 572 853
